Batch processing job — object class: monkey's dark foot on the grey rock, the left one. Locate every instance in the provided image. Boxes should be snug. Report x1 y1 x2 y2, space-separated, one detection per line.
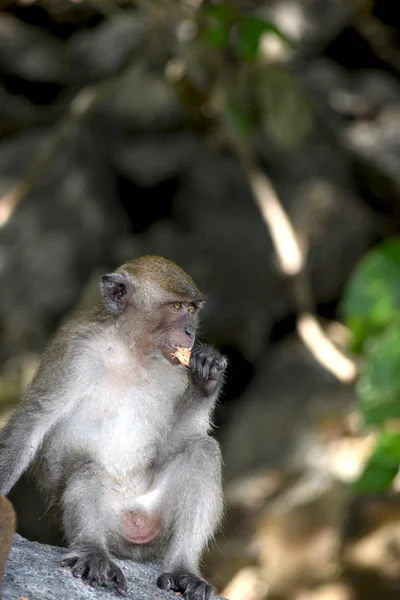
61 551 128 594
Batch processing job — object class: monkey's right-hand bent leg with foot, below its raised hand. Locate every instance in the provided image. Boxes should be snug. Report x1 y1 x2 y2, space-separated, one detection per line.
157 436 223 600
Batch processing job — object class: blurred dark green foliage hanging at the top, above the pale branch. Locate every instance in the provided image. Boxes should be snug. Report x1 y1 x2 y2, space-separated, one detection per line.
174 2 312 151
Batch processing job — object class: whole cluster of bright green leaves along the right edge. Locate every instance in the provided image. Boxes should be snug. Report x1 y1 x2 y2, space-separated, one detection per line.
342 237 400 492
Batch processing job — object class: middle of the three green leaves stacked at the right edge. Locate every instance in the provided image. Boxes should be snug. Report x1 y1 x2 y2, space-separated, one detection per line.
357 325 400 425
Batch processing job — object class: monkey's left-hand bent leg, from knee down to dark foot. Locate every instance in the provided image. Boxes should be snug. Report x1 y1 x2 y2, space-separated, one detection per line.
61 458 127 594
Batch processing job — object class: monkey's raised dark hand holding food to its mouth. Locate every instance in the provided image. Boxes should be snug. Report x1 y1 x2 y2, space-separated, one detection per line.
189 346 228 396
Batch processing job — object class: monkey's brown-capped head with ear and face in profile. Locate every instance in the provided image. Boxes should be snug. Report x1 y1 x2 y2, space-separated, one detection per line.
100 256 204 363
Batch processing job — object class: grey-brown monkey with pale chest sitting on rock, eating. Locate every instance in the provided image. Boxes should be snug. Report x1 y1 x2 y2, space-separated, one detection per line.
0 256 227 600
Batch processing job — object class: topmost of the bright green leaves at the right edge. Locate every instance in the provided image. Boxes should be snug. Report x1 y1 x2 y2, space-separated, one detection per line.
341 237 400 352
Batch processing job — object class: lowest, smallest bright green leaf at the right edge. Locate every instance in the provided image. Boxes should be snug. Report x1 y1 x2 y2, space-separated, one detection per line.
353 431 400 493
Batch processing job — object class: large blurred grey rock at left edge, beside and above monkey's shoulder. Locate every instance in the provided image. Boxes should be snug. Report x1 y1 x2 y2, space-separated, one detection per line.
0 130 125 358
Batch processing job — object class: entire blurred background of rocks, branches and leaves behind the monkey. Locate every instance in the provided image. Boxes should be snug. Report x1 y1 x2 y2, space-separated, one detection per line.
0 0 400 600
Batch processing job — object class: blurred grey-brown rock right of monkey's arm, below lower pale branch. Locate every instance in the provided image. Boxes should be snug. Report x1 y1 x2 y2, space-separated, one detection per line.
221 339 355 482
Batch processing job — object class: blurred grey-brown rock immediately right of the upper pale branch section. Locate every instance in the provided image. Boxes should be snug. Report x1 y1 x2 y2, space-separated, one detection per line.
269 134 382 305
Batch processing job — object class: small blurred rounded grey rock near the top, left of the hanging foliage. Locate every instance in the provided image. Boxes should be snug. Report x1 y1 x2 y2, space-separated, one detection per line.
67 11 145 81
